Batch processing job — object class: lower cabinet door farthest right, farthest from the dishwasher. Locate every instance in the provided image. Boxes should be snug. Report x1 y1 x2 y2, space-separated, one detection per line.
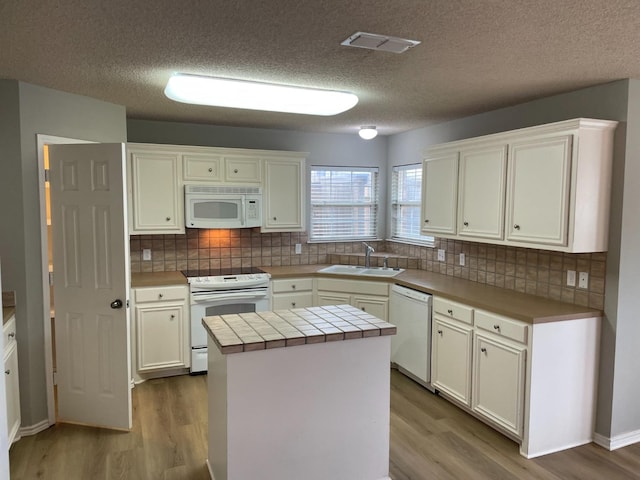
472 333 526 437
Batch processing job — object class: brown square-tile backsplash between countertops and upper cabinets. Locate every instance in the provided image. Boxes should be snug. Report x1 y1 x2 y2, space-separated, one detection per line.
130 229 607 309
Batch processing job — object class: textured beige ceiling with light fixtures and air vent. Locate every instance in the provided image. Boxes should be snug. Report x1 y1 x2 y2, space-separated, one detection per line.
0 0 640 135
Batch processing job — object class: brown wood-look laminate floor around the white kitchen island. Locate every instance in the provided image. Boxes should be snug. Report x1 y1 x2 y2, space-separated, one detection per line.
10 371 640 480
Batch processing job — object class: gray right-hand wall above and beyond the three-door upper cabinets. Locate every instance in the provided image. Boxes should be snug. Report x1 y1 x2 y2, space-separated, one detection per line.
388 80 640 437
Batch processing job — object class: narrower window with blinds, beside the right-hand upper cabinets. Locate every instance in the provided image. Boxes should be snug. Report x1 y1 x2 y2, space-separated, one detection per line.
391 163 434 246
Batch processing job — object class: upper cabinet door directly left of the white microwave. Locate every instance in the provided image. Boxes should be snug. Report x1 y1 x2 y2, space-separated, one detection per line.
128 150 184 234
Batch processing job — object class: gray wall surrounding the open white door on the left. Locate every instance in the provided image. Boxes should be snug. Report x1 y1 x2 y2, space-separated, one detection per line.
0 80 126 426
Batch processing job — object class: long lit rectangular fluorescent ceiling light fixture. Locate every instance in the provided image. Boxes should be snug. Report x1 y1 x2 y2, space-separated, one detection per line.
164 73 358 116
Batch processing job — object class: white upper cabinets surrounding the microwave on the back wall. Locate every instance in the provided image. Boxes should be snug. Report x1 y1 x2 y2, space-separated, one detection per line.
127 143 306 235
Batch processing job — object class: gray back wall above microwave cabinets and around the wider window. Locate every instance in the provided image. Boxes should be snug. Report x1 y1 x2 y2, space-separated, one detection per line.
127 120 387 237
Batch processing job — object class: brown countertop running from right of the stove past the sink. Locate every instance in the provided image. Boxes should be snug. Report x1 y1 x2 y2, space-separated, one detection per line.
260 265 603 324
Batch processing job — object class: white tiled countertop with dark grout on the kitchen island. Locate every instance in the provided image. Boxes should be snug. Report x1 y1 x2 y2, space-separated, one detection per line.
202 305 396 354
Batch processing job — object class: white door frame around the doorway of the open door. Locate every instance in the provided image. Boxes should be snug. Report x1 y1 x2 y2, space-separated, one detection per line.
34 133 96 426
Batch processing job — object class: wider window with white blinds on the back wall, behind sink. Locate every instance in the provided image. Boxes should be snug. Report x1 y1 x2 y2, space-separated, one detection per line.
309 166 378 242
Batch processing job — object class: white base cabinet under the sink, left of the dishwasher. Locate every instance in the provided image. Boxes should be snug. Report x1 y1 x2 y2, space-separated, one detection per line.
314 277 389 322
